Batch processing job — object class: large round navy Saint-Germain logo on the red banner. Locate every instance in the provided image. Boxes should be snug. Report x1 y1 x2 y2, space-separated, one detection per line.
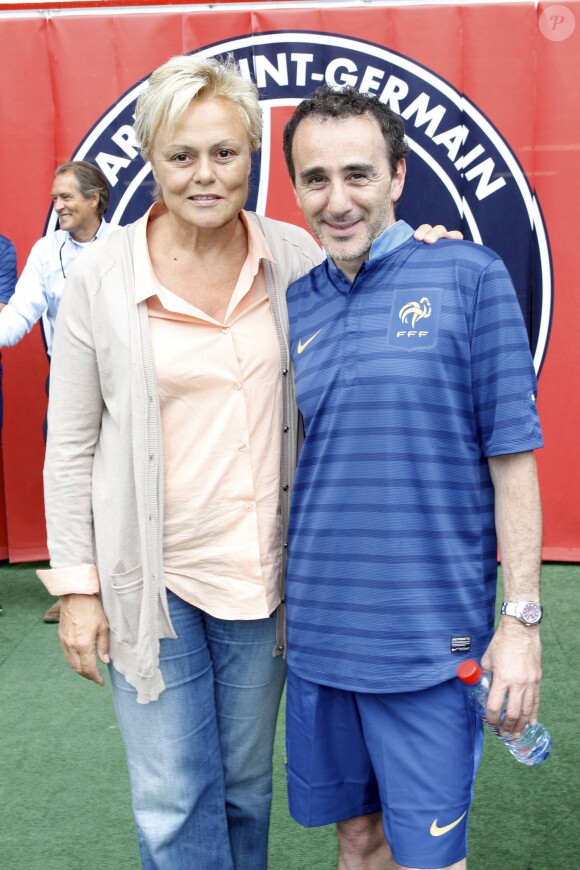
47 32 552 371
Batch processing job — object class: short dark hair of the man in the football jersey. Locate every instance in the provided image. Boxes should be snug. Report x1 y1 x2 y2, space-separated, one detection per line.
283 85 410 183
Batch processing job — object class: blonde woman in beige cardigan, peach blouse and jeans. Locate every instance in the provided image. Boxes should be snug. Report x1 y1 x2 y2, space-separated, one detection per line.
39 56 456 870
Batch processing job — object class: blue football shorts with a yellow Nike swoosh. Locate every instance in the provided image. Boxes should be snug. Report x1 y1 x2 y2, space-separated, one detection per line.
286 671 483 868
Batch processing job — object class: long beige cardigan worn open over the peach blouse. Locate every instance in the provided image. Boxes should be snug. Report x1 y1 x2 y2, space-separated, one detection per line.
38 216 323 703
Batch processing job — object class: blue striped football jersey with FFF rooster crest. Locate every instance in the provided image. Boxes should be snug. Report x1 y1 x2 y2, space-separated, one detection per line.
286 222 542 692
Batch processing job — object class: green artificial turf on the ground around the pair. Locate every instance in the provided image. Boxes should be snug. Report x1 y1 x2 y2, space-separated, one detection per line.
0 564 580 870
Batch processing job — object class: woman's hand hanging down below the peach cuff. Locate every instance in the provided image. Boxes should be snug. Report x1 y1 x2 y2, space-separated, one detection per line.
58 595 110 686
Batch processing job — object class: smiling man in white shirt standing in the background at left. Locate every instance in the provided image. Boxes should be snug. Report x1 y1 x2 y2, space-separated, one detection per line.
0 160 112 623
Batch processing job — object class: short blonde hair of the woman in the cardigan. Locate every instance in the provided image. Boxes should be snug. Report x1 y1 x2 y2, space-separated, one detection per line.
135 54 262 160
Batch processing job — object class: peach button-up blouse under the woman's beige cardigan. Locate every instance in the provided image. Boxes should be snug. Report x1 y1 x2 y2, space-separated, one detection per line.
134 206 282 619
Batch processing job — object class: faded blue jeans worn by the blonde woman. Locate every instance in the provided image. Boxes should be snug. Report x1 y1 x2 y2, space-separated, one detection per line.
110 592 285 870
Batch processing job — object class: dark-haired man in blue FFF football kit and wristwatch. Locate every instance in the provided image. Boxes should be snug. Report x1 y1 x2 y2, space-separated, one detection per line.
284 87 542 870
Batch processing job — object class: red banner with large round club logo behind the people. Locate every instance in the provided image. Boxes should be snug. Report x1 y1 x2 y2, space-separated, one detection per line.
0 0 580 561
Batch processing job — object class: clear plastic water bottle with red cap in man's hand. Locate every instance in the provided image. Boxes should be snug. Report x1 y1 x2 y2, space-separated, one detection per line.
457 659 552 766
